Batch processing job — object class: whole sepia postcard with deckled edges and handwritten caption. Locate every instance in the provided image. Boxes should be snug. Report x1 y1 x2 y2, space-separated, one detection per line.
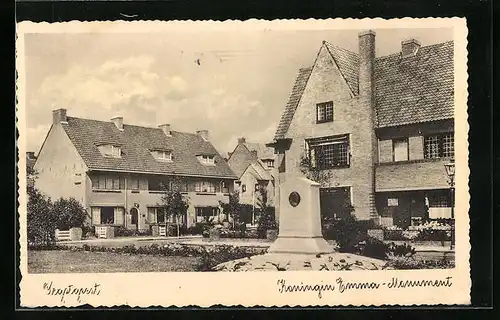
17 18 470 306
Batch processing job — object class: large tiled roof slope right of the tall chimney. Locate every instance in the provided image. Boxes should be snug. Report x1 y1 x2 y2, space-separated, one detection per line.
375 41 454 127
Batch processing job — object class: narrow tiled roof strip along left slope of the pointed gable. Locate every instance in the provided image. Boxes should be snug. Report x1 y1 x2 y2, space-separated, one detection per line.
275 67 313 139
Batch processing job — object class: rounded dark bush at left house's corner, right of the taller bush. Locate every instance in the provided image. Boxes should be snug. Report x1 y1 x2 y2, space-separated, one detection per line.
53 198 87 230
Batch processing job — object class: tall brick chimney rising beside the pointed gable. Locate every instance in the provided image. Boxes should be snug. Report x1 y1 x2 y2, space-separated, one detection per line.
358 30 375 99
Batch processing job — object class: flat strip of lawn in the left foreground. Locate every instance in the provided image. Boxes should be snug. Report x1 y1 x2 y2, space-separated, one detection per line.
28 250 199 273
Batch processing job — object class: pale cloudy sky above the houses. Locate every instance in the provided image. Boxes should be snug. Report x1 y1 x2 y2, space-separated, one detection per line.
25 28 453 153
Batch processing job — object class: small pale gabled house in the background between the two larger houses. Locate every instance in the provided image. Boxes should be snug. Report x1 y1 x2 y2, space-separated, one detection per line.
227 138 278 224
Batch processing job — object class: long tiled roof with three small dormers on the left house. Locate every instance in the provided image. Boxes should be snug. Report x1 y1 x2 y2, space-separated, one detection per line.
61 117 236 179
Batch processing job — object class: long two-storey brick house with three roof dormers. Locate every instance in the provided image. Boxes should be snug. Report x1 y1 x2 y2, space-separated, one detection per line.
34 109 236 230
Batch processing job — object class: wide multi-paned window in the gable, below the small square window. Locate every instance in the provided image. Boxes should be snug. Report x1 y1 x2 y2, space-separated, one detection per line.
306 135 350 169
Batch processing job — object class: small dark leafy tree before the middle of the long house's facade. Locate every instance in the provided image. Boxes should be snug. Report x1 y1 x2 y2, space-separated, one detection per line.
161 176 189 237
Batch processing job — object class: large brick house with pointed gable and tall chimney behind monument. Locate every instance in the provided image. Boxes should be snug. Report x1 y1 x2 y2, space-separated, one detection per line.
268 31 454 227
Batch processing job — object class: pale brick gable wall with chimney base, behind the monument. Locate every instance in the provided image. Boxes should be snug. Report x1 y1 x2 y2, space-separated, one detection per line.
285 43 377 219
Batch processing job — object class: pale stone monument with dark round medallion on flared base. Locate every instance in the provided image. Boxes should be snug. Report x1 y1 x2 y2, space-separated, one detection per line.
268 177 333 254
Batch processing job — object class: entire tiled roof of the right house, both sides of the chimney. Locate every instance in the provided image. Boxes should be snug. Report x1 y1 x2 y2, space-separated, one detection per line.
275 41 454 140
